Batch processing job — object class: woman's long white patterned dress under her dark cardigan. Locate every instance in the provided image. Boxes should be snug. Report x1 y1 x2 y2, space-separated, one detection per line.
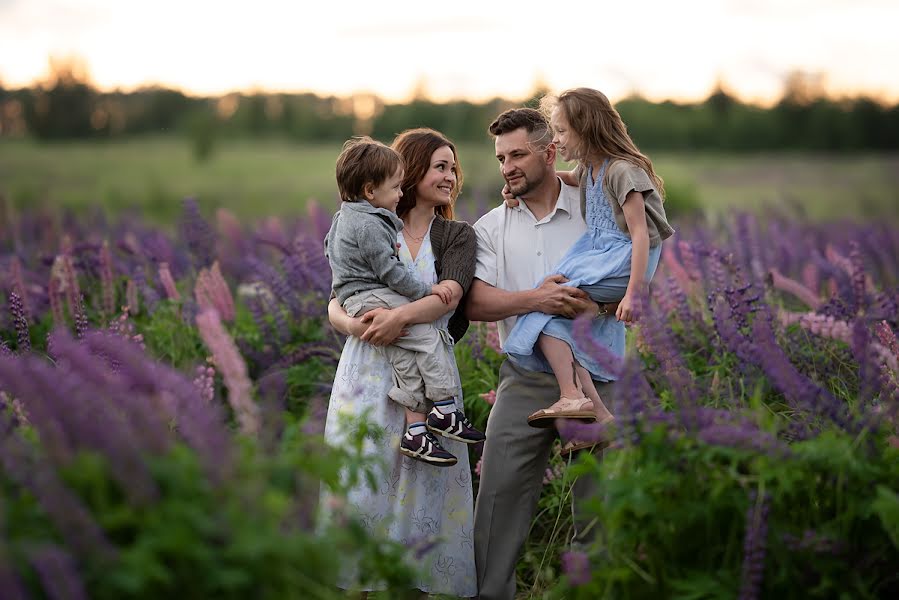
323 223 477 598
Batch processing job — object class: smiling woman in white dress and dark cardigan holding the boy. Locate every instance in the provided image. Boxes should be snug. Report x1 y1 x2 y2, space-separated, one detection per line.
325 129 477 597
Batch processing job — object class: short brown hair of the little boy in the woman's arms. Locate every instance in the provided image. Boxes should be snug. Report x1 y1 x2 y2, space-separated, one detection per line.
336 136 403 202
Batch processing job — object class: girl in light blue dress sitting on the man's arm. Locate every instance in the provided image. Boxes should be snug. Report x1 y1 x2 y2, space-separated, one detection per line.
503 88 674 442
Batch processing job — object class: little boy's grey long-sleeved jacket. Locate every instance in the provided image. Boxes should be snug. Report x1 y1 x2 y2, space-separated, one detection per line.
325 200 431 305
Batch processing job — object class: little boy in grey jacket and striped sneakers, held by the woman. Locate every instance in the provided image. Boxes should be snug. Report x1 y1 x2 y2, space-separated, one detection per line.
325 137 484 466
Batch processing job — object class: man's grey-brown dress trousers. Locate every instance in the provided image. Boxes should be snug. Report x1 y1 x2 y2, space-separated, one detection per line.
474 360 613 600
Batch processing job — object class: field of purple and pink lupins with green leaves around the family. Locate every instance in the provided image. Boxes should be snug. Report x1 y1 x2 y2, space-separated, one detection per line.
0 195 899 599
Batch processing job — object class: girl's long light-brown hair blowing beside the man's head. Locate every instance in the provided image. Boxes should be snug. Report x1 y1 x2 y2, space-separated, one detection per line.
540 88 665 199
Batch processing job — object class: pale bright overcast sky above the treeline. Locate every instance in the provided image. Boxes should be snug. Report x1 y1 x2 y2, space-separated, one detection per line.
0 0 899 101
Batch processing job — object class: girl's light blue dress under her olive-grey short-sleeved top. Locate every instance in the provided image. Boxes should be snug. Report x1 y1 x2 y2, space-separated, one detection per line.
503 160 662 381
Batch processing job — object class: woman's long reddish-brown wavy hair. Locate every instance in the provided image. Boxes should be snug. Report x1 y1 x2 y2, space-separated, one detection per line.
391 127 462 220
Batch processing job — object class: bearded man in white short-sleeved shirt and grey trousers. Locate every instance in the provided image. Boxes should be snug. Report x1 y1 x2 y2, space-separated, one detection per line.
466 108 611 600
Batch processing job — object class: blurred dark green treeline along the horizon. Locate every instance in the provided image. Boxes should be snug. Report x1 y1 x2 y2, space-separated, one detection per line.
0 63 899 155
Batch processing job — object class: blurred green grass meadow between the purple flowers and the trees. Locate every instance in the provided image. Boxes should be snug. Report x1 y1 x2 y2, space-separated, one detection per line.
0 137 899 222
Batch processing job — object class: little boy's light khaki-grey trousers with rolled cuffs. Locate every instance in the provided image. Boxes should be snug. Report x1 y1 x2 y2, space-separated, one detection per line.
343 288 459 413
